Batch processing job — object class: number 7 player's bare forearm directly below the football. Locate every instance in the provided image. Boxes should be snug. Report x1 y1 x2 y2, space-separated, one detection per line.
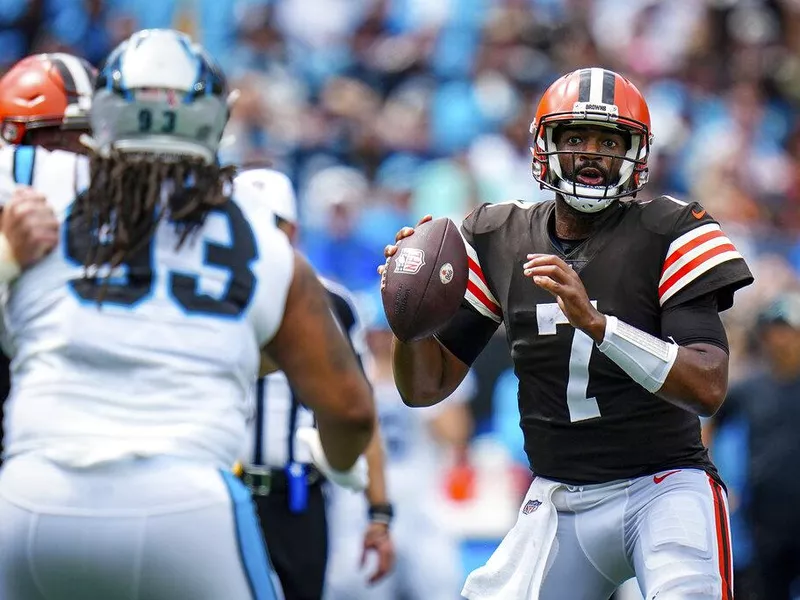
392 337 463 406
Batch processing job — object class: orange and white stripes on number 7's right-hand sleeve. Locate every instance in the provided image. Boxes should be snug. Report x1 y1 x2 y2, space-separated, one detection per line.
658 223 742 306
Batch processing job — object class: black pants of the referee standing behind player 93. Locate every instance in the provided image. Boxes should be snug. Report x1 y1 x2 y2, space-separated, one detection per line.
253 481 328 600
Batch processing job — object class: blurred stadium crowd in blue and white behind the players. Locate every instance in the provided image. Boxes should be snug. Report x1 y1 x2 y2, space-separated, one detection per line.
0 0 800 598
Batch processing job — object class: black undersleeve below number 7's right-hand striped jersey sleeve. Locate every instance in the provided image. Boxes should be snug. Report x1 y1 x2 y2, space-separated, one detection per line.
661 292 728 352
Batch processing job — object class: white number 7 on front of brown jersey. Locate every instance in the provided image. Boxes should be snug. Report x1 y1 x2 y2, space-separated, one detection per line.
536 300 600 423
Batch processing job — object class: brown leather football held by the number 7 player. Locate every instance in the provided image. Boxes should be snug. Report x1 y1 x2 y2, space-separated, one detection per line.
381 218 469 342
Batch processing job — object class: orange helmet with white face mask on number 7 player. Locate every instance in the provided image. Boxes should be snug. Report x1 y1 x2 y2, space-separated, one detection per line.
530 68 653 212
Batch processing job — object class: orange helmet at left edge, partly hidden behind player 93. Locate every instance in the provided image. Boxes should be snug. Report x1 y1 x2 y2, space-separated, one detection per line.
0 53 97 144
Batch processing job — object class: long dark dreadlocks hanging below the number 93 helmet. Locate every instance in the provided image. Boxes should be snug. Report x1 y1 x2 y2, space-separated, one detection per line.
73 150 235 303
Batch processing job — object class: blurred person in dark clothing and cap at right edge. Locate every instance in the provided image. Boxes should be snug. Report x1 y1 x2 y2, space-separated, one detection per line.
714 291 800 600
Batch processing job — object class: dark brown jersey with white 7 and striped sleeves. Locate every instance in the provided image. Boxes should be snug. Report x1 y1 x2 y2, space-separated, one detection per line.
436 196 753 484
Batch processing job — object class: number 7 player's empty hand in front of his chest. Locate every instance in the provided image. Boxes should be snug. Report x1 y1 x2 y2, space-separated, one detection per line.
522 254 606 343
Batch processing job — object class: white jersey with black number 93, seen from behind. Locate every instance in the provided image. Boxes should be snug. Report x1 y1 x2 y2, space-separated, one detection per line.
0 156 294 474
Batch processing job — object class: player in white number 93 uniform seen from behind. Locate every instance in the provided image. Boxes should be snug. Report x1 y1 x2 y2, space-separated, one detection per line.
0 30 374 600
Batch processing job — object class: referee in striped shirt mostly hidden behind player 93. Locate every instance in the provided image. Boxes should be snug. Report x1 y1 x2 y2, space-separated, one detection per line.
237 168 395 600
